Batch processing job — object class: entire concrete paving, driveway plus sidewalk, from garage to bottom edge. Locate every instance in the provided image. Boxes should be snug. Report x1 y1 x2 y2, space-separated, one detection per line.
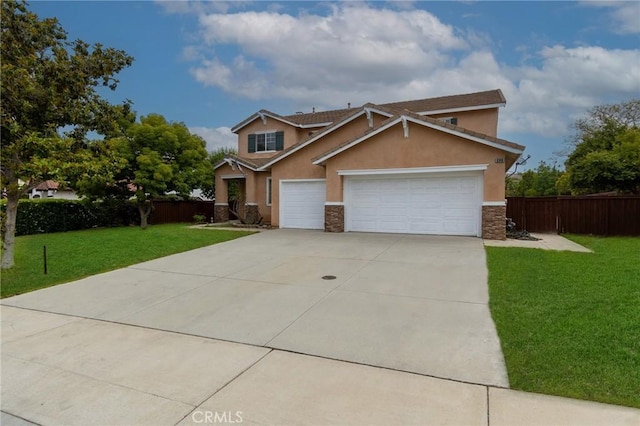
5 231 640 426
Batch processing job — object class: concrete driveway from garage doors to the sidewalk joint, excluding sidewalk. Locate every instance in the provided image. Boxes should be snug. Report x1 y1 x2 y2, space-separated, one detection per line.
2 230 508 387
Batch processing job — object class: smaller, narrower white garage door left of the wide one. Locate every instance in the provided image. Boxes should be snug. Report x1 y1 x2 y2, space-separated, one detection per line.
280 180 327 229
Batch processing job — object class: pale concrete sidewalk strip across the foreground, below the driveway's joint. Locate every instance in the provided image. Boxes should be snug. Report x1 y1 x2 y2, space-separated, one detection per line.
0 306 640 426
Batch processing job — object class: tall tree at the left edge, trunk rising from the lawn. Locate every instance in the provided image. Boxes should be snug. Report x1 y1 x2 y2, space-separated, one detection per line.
0 0 133 268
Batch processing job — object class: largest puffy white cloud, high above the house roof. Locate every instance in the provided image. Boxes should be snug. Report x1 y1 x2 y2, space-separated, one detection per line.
193 4 467 103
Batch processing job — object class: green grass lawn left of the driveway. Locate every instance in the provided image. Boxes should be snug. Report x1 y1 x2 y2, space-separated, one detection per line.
0 224 252 297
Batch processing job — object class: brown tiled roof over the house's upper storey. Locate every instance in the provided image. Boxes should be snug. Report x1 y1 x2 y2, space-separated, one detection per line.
231 89 507 133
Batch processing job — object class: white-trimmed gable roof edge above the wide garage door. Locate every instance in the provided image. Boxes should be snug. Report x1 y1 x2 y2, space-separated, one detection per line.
312 110 525 165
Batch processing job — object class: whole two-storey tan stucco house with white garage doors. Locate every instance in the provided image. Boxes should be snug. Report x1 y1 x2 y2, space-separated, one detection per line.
215 90 525 239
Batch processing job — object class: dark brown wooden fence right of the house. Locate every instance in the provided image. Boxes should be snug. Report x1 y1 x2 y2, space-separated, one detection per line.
507 196 640 235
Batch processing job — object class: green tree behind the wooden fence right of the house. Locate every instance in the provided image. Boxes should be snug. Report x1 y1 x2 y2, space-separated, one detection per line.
561 99 640 194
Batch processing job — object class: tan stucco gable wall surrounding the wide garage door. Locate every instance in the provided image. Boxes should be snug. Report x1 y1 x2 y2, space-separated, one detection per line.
326 123 505 201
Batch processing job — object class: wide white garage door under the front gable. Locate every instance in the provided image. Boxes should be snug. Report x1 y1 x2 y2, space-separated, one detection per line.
345 175 483 236
